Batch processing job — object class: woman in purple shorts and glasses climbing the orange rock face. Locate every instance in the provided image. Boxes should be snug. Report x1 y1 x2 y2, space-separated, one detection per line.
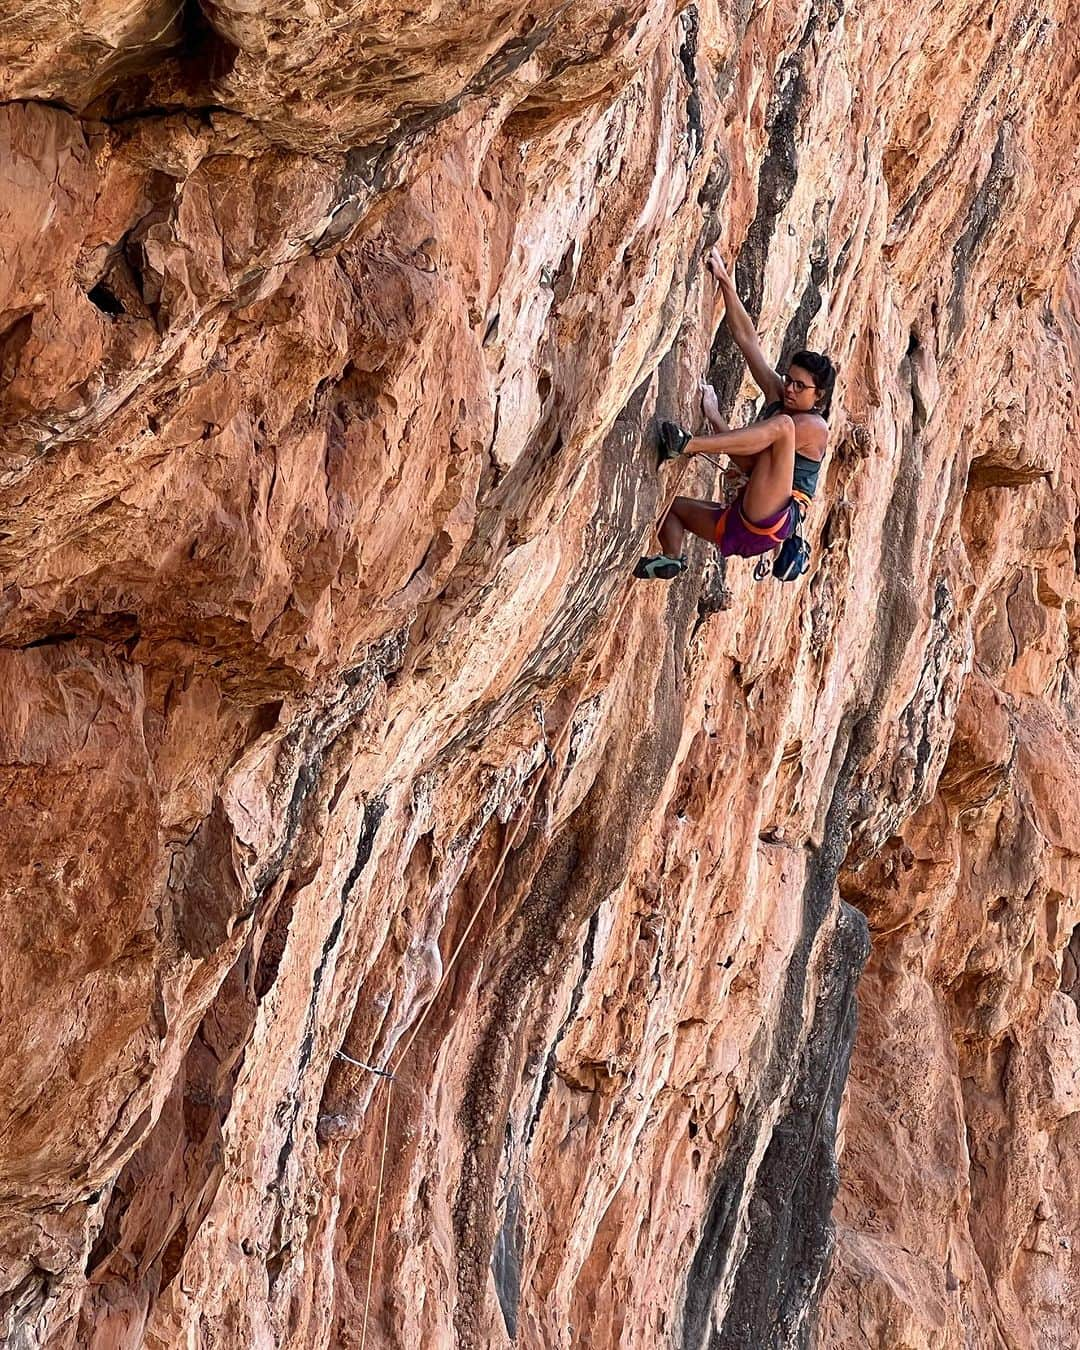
633 248 836 581
